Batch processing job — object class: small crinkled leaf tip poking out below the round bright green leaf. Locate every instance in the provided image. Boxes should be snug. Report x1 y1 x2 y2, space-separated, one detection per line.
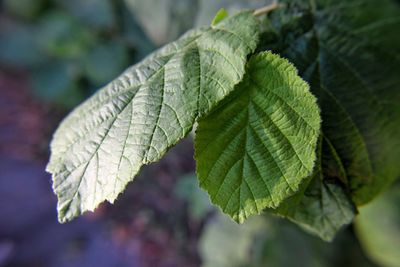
273 137 356 241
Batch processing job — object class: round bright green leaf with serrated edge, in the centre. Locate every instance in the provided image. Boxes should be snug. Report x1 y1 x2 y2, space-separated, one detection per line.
195 53 320 223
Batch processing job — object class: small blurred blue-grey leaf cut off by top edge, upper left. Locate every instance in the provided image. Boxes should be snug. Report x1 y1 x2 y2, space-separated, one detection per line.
52 0 115 30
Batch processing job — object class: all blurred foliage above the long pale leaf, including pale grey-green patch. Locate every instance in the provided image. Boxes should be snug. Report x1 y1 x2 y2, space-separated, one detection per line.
0 0 270 108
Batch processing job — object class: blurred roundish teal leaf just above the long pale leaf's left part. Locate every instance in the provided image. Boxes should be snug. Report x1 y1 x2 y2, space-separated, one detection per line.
31 62 83 108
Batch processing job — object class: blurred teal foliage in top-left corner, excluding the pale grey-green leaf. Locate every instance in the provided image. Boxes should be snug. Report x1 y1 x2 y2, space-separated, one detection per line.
0 0 155 108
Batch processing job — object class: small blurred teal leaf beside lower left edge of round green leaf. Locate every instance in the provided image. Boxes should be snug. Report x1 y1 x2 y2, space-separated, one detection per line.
175 174 213 220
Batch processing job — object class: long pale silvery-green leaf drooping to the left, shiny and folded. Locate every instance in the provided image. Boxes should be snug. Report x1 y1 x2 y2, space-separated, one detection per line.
47 12 258 222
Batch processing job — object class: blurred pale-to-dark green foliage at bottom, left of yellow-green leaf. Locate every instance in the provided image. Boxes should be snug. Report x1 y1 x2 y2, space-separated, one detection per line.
199 214 377 267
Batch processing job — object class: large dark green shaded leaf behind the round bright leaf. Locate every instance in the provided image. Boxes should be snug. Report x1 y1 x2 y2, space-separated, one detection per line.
260 0 400 205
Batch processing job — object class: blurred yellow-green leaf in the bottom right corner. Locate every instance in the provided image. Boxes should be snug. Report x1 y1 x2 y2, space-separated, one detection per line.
355 184 400 267
